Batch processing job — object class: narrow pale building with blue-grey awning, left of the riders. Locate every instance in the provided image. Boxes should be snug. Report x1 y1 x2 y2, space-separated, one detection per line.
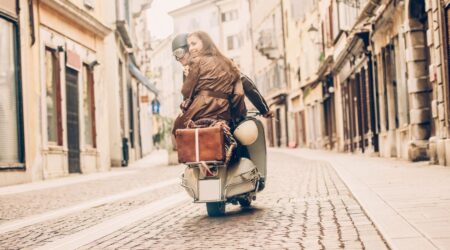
104 0 157 167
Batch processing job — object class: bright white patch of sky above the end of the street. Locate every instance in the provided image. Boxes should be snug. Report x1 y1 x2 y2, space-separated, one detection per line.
147 0 191 39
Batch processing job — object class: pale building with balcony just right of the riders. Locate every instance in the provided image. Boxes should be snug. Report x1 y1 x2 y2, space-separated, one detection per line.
249 0 290 147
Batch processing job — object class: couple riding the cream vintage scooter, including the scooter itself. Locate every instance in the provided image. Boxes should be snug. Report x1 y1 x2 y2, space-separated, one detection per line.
172 31 273 216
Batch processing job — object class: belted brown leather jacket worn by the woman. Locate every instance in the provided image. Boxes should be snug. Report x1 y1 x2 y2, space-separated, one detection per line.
172 56 245 134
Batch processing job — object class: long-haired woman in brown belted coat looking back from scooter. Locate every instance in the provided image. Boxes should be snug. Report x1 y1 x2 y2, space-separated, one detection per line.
173 31 244 137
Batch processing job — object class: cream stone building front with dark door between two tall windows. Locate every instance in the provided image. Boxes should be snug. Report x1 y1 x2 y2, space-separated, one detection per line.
36 2 110 179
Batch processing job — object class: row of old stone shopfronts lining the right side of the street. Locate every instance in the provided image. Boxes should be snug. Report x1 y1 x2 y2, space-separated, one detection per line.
292 0 450 165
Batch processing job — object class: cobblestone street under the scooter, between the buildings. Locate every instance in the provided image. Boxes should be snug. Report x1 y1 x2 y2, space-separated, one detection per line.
0 152 394 249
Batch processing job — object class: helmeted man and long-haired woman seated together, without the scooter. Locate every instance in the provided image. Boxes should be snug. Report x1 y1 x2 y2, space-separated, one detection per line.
172 31 273 148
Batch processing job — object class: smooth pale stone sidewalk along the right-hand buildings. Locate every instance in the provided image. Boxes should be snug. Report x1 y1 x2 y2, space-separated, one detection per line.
272 149 450 249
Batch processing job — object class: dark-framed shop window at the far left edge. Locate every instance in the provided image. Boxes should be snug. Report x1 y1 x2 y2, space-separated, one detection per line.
0 0 25 172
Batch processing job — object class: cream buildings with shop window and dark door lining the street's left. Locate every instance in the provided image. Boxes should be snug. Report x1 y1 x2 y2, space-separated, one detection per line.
0 0 156 186
